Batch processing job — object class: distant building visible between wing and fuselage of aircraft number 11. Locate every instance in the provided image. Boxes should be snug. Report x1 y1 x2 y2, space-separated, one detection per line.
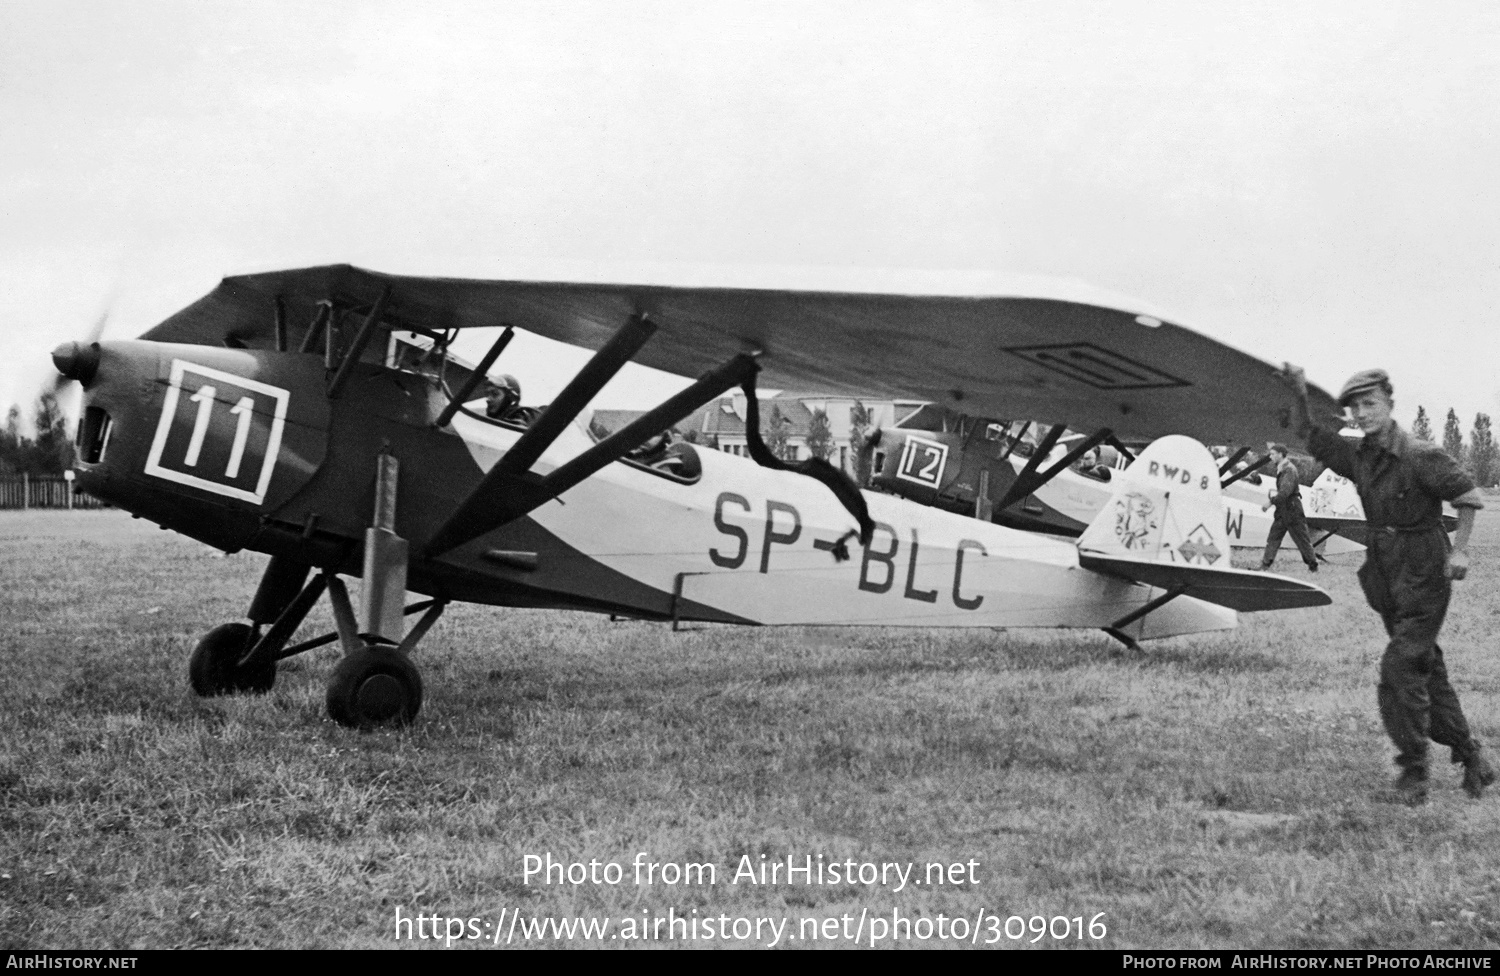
593 393 923 472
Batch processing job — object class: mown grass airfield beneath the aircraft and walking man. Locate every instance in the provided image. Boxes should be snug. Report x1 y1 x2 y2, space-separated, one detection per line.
0 507 1500 949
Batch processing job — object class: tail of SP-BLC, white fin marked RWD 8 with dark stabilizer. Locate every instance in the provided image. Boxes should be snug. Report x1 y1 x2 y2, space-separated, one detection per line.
1079 435 1332 610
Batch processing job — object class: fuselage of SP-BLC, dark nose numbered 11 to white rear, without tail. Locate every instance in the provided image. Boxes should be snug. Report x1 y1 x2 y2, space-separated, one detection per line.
67 342 1235 637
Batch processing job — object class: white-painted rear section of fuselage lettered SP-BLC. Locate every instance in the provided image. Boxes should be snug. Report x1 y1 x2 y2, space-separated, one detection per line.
455 414 1236 637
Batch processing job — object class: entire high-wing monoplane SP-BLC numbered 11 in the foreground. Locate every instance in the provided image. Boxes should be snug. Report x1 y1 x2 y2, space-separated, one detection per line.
53 265 1337 727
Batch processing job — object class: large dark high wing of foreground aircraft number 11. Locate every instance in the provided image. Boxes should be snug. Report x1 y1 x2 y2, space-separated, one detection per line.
143 265 1337 444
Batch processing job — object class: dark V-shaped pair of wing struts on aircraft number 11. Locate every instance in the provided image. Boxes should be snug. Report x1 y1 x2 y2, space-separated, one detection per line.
426 315 756 558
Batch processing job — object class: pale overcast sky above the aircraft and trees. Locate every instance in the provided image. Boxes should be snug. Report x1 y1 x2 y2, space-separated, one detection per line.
0 0 1500 430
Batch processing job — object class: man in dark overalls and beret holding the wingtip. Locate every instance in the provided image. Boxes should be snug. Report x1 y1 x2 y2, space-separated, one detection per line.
1286 363 1496 805
